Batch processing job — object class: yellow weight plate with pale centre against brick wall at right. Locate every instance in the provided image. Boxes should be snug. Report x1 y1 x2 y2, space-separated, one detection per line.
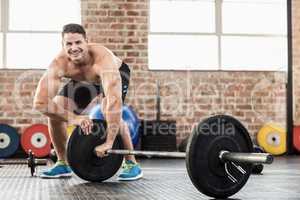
257 123 286 155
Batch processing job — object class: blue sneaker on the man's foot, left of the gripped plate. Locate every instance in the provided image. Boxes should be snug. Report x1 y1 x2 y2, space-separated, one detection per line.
39 161 72 178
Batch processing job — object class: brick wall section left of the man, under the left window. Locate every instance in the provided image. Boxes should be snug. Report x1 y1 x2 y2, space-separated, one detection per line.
0 70 46 133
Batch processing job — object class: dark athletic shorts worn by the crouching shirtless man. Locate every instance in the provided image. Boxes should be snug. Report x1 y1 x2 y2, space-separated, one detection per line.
57 63 130 114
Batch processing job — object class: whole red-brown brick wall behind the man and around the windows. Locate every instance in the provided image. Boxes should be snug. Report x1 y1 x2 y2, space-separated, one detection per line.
0 0 292 147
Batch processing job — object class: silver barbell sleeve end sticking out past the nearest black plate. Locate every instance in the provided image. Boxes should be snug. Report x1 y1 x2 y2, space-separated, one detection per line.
219 151 274 164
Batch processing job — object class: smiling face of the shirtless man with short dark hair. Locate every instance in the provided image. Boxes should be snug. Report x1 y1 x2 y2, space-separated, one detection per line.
62 33 88 64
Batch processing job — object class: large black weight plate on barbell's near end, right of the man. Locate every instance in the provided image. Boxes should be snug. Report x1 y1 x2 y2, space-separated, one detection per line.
186 115 253 198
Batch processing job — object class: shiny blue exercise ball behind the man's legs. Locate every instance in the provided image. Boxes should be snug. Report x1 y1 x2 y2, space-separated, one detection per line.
89 105 140 146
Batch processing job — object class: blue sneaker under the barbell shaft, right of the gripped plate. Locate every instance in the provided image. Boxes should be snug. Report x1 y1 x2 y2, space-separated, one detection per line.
118 160 143 181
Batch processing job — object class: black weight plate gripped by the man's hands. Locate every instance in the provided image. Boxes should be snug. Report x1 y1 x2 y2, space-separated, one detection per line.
67 120 123 182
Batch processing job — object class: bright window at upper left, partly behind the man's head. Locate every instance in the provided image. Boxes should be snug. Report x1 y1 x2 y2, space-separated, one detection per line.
0 0 81 69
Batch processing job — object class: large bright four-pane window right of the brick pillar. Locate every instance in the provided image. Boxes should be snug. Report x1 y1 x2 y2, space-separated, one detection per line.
148 0 288 71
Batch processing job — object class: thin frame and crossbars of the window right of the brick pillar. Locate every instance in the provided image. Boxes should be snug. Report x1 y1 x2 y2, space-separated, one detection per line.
148 0 289 72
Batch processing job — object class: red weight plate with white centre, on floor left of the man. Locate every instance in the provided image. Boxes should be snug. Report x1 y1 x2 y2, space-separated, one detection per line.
21 124 51 158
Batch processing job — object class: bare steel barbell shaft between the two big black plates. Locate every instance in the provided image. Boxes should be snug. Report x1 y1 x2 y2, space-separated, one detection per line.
107 149 186 158
